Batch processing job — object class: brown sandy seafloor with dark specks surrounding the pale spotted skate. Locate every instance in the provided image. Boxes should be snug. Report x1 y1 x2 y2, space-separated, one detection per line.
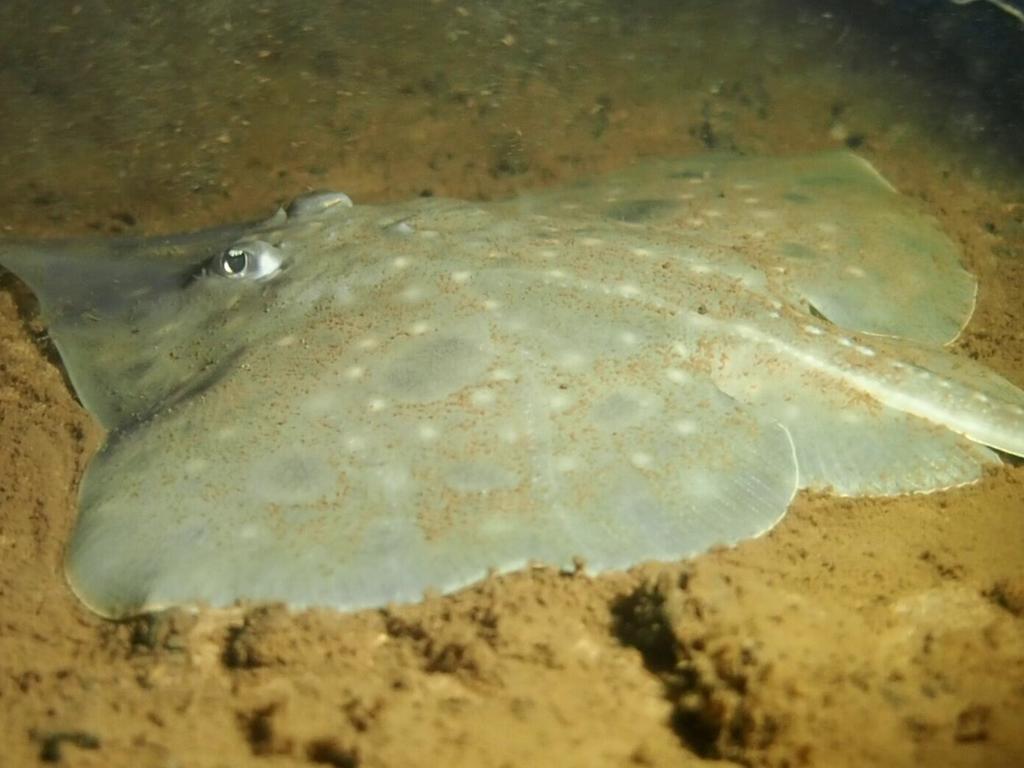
0 0 1024 768
